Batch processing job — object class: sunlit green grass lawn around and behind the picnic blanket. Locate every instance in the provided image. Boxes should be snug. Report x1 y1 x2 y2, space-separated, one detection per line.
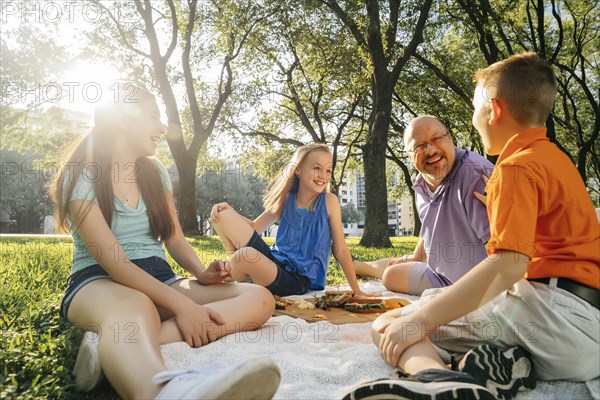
0 236 416 399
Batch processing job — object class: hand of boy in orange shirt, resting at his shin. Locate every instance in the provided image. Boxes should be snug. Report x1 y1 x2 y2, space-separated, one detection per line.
379 315 426 368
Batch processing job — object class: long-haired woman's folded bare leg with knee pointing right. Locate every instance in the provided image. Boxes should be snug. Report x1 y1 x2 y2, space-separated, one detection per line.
159 279 275 344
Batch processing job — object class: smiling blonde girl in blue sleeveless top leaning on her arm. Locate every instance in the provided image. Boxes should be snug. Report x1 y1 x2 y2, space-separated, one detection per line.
211 143 364 296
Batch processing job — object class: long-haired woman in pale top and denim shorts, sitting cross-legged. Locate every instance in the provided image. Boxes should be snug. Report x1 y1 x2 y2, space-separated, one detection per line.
52 82 280 399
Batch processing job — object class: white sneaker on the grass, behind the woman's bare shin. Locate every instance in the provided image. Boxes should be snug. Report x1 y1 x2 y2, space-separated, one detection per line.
73 332 104 392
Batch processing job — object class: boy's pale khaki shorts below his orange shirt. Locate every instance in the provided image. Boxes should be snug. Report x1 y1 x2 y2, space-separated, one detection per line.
403 278 600 382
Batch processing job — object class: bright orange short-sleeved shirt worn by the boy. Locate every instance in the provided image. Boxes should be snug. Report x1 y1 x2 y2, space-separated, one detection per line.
486 128 600 289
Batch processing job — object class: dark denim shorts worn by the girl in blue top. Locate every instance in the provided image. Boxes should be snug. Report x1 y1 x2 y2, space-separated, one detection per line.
246 231 310 296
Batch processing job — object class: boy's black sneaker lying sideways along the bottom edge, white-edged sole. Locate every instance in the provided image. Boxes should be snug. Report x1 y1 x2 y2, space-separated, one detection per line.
344 369 495 400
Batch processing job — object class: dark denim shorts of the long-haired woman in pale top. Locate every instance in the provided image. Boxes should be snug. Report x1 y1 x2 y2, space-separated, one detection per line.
60 256 184 319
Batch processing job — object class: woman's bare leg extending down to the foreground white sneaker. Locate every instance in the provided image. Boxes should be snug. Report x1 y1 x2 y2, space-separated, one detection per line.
68 279 166 399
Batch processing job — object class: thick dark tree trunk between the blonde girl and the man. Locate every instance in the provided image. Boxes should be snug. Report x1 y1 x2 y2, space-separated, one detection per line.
360 80 393 247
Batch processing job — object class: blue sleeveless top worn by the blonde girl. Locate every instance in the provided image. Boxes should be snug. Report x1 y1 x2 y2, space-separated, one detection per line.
271 192 331 290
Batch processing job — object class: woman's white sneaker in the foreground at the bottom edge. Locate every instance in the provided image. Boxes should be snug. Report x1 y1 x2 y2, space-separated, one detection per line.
152 357 281 400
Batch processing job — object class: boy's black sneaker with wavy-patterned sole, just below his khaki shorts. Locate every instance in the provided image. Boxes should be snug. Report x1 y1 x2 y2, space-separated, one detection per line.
459 344 536 399
